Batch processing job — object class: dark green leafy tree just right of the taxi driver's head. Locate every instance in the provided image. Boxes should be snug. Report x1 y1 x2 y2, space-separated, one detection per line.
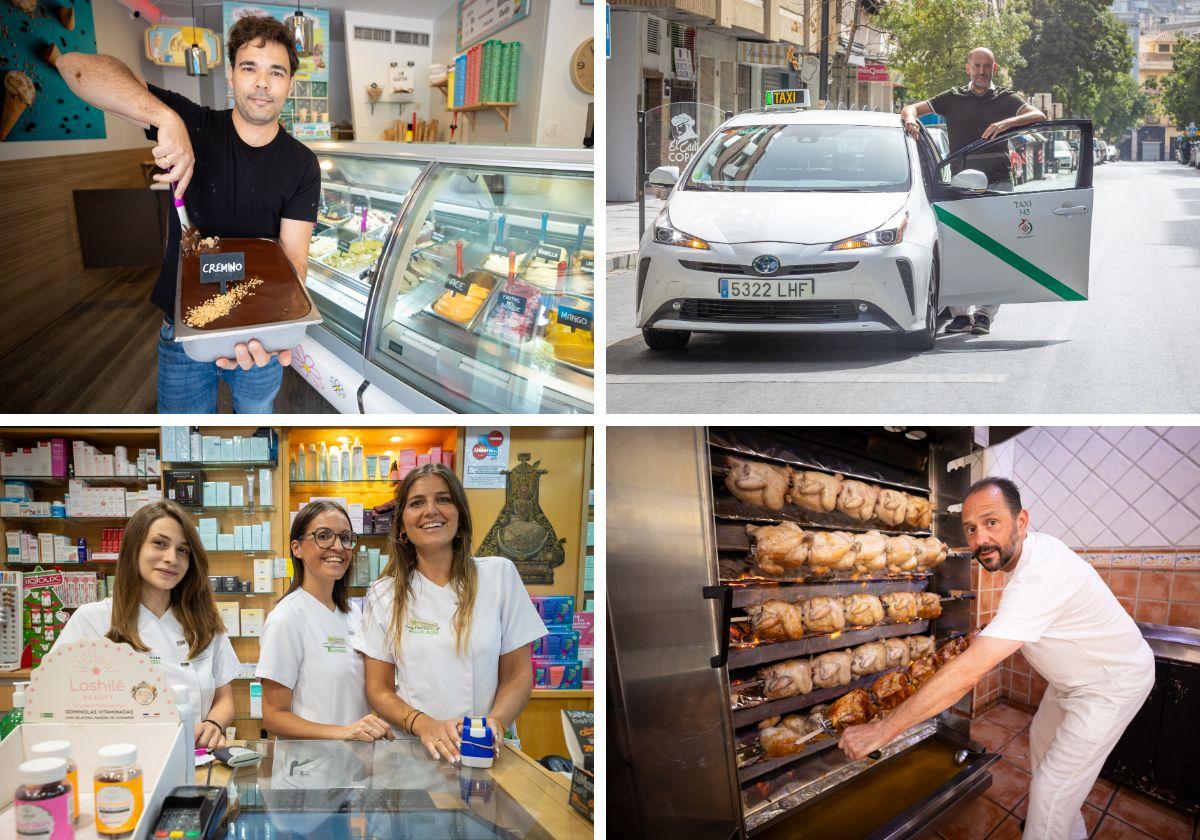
1013 0 1134 115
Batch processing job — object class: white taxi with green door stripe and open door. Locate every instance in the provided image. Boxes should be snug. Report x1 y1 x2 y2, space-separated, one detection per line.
637 102 1092 350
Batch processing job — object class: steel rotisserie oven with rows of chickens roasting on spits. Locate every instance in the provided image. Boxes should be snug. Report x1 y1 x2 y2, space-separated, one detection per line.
607 427 998 840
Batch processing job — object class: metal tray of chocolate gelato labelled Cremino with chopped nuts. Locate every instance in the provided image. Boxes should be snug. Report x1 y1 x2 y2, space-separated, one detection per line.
175 228 323 361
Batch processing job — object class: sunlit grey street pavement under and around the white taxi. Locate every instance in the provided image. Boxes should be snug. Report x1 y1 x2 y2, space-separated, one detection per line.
606 162 1200 414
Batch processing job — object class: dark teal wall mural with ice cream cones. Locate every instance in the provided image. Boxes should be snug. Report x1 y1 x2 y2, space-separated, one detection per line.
0 0 104 143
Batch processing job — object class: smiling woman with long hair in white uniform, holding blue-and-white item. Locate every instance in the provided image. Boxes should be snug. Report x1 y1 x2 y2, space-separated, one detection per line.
356 464 546 762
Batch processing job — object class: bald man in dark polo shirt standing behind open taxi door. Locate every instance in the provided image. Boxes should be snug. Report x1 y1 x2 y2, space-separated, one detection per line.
900 47 1046 335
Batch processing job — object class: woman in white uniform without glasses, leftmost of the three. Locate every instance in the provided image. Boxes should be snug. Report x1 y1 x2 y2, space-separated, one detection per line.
55 500 239 748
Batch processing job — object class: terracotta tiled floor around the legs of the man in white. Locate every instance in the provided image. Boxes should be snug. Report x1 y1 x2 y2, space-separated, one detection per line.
925 703 1200 840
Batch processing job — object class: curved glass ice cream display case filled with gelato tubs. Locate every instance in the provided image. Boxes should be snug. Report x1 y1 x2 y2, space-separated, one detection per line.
294 143 595 413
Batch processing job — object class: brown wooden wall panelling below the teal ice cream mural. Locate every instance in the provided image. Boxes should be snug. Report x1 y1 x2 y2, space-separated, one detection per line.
0 149 149 356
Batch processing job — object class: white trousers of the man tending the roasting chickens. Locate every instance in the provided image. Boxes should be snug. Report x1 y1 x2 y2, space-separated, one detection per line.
1021 671 1154 840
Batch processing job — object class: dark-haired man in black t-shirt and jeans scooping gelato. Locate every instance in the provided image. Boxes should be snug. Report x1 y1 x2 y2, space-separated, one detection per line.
58 17 320 414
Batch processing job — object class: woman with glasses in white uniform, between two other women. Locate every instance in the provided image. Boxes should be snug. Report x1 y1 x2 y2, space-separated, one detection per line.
254 500 391 740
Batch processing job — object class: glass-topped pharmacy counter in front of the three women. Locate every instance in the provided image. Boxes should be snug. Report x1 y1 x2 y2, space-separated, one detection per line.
196 738 593 840
